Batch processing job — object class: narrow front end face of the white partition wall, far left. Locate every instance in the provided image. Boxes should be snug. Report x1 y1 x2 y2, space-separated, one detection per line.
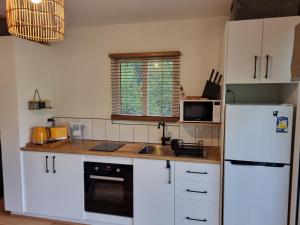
0 37 23 212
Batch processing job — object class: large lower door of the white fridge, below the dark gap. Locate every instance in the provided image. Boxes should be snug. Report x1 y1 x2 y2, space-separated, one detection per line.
224 161 290 225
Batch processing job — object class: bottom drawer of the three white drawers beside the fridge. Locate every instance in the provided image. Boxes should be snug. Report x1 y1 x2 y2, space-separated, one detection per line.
175 199 219 225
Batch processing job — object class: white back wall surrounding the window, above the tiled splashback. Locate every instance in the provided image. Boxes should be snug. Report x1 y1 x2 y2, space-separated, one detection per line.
52 18 226 118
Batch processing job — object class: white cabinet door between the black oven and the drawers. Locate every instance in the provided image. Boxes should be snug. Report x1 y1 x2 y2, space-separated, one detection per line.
133 159 175 225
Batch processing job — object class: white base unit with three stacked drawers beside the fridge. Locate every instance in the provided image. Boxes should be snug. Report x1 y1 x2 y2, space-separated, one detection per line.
175 162 220 225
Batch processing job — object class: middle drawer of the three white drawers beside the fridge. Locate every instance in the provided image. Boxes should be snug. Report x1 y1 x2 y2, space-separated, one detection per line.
175 180 220 203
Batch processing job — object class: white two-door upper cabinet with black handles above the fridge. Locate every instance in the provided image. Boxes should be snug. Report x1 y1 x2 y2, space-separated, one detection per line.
226 16 300 84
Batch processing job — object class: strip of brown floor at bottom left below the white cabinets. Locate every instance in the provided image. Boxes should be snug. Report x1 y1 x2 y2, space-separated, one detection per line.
0 199 78 225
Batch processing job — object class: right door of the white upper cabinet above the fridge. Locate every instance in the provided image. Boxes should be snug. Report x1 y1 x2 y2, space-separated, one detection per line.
260 16 300 83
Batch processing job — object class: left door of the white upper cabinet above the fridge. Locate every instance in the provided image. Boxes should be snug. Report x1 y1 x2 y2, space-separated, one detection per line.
226 20 263 84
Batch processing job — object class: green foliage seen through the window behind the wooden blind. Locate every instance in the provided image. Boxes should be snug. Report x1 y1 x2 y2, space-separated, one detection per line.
120 60 173 116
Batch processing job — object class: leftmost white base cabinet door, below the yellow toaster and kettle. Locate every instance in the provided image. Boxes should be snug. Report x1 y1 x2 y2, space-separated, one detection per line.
22 152 53 215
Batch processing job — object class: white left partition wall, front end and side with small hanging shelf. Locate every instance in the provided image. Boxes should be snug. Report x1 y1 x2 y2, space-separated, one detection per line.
0 37 53 212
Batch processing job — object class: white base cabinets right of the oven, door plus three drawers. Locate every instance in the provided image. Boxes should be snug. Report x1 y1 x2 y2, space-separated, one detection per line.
133 159 220 225
